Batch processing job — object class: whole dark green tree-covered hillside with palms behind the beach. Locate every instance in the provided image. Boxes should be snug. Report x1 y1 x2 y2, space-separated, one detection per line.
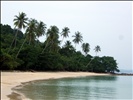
0 12 119 73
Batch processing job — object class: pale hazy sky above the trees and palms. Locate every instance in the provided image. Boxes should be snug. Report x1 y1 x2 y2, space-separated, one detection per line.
1 1 133 70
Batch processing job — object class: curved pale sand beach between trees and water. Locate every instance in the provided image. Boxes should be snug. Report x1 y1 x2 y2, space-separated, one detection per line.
1 72 109 100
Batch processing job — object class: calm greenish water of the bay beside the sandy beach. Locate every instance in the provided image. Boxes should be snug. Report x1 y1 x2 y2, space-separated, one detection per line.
14 76 133 100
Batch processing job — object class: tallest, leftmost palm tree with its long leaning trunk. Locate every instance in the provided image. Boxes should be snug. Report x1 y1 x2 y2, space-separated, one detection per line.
8 12 28 53
